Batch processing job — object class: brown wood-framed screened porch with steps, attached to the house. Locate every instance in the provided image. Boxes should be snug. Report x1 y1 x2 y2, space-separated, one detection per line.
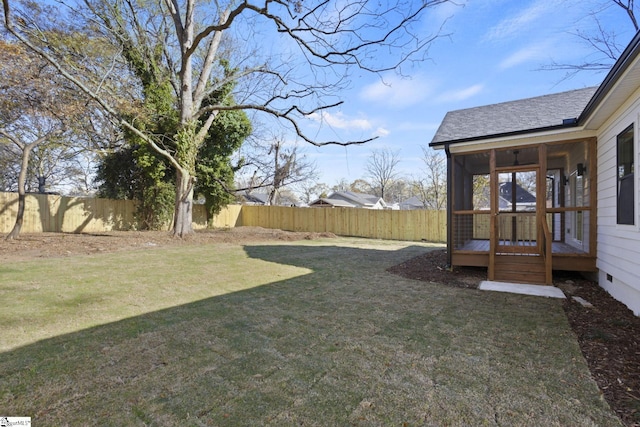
450 139 596 282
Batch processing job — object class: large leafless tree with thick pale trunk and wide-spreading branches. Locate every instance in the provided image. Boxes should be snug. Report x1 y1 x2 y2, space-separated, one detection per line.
2 0 447 236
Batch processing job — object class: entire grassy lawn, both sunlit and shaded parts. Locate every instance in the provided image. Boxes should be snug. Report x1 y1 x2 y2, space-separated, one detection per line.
0 239 619 426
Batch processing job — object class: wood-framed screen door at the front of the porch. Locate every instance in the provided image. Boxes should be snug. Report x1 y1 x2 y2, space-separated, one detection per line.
491 165 544 255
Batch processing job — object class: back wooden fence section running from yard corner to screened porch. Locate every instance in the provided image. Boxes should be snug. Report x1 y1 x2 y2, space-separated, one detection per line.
241 206 447 242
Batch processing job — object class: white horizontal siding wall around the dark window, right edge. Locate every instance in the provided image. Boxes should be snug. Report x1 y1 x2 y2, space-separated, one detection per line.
597 92 640 315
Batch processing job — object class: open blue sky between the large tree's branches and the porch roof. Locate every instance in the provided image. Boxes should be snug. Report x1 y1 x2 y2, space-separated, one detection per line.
292 0 634 186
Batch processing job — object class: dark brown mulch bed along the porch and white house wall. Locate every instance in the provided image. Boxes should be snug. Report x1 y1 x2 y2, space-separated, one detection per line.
389 250 640 427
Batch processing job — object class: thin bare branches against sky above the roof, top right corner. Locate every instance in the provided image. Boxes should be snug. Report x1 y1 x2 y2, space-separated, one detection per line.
541 0 640 79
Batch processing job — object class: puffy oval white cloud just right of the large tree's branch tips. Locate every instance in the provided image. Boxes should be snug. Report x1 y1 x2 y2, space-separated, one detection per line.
360 76 432 108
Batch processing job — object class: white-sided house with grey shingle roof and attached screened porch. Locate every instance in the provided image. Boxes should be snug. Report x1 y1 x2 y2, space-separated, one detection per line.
430 33 640 315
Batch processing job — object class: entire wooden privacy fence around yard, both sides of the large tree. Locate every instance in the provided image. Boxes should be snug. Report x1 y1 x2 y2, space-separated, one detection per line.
0 192 447 242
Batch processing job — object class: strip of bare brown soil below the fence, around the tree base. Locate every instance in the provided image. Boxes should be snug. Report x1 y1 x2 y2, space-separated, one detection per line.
0 227 336 262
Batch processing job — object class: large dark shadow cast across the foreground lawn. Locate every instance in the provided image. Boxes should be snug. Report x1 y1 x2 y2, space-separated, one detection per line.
0 245 616 426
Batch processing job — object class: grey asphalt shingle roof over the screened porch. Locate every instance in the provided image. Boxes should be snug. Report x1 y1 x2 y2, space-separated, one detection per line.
431 87 598 144
